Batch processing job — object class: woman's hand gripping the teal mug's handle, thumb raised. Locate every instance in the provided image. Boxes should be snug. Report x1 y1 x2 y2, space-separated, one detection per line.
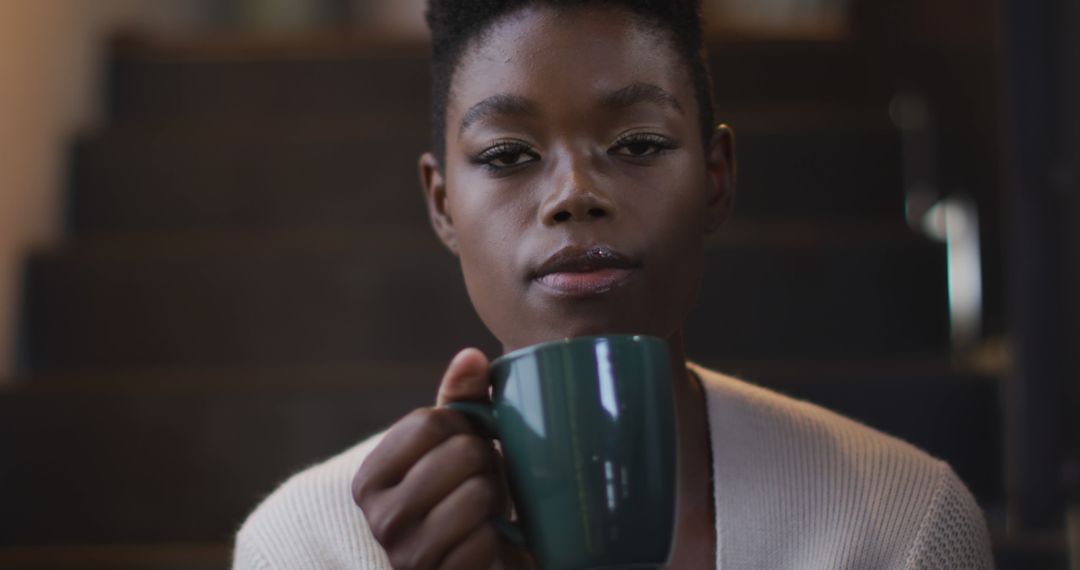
352 349 531 570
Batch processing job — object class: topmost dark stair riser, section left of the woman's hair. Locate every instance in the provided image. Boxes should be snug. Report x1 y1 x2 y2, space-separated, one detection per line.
108 34 431 119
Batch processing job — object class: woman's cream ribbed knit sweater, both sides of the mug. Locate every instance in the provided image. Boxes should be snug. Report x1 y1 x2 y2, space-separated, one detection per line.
233 365 993 570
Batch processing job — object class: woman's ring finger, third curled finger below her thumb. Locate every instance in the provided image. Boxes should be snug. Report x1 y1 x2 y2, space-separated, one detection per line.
403 476 496 568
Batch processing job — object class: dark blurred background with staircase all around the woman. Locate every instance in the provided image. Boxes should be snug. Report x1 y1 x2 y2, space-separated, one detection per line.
0 0 1080 569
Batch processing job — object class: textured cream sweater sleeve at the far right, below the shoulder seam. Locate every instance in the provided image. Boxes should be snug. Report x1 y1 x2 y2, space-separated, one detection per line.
904 462 994 570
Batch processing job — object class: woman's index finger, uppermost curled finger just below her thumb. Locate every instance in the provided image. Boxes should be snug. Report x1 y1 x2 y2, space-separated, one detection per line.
352 408 473 500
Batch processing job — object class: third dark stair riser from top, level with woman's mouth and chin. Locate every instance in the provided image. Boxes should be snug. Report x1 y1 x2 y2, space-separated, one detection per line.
19 226 948 369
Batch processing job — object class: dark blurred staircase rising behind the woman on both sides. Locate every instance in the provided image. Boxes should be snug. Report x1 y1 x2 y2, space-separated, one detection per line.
0 34 1019 568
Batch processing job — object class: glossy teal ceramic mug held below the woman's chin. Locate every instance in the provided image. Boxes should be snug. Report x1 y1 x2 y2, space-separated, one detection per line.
448 336 677 570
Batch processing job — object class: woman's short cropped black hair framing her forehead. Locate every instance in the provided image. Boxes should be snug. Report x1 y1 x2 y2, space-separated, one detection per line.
426 0 715 165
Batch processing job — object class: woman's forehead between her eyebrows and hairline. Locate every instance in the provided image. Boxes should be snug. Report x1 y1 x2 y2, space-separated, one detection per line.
447 5 693 119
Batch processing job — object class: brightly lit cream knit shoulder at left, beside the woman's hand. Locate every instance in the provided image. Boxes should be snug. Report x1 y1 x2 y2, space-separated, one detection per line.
233 434 390 570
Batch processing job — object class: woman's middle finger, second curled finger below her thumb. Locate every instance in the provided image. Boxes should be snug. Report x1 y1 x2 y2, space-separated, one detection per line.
391 435 501 526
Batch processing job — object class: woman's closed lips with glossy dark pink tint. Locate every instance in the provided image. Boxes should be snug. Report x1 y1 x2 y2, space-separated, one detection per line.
532 245 638 296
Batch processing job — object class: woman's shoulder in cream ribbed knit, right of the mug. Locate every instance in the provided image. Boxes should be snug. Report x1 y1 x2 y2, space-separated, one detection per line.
692 366 989 568
